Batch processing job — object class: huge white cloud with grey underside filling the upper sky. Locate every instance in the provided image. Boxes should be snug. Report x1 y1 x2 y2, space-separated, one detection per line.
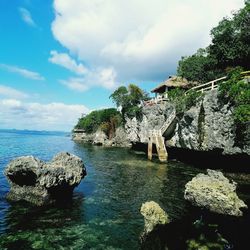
52 0 244 81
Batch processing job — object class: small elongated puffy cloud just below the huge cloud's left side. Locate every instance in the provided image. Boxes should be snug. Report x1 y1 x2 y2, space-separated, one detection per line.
49 50 87 75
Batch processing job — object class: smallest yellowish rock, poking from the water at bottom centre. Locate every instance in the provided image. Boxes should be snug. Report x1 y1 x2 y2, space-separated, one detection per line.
141 201 169 234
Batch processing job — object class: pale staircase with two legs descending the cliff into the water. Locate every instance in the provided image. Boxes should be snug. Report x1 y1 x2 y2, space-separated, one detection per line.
148 111 176 162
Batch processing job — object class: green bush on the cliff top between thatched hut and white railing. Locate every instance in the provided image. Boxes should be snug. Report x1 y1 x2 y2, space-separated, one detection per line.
168 88 204 114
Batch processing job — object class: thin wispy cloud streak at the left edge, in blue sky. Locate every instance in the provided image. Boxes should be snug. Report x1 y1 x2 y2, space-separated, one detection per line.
0 64 45 81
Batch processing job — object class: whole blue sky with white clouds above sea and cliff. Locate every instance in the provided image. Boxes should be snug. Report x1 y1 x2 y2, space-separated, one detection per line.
0 0 244 131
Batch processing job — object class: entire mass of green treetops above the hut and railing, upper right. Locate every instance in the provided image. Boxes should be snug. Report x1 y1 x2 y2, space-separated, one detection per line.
177 1 250 83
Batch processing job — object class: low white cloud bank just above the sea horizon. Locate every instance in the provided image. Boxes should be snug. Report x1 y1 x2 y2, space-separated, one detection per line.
0 99 89 131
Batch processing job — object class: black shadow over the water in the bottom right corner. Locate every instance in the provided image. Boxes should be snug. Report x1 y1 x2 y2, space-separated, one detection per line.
141 207 250 250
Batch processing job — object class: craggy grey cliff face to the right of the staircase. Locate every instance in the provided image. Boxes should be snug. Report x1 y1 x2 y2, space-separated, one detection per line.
168 90 250 155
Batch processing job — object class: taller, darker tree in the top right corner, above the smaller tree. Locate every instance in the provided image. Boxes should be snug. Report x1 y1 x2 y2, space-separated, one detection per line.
208 1 250 69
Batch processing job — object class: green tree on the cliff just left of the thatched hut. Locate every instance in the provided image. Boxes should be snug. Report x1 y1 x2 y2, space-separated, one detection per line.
110 84 148 121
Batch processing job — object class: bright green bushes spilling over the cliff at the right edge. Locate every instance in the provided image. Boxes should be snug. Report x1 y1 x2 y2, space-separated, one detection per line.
219 67 250 124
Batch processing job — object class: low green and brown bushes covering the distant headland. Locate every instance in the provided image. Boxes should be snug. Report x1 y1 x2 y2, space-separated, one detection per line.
75 108 121 138
